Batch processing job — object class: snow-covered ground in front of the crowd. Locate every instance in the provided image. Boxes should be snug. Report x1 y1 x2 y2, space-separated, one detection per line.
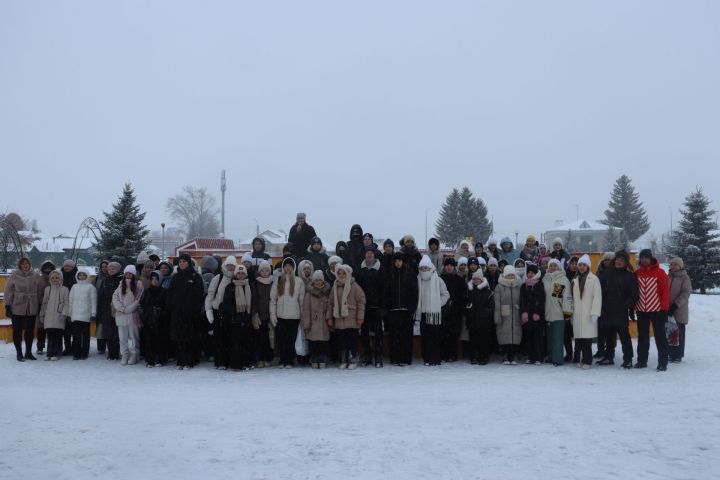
0 295 720 480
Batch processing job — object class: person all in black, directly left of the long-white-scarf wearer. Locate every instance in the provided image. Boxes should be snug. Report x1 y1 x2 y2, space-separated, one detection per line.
387 252 418 366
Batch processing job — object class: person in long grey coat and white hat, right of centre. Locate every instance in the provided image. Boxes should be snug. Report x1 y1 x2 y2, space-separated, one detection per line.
495 265 522 365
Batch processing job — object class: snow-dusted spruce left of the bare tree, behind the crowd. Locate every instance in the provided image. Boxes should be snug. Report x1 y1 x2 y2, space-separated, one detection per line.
95 183 149 265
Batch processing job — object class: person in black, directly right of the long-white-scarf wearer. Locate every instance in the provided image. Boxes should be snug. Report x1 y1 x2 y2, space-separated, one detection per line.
440 257 468 362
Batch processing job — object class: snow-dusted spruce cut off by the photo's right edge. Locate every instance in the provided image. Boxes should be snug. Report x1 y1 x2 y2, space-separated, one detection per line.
668 187 720 293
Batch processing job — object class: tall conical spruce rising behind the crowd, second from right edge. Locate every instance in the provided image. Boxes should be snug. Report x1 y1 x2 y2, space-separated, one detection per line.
601 175 650 243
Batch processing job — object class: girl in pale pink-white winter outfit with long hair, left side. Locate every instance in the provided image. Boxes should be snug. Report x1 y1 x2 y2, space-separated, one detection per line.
113 265 143 365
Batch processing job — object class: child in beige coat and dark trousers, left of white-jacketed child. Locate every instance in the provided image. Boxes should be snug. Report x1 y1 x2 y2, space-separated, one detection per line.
40 270 70 361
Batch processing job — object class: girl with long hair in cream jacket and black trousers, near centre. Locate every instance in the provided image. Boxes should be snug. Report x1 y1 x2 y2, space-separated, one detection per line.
270 258 305 368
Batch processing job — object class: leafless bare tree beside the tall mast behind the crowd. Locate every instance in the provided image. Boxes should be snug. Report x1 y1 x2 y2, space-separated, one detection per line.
165 185 220 238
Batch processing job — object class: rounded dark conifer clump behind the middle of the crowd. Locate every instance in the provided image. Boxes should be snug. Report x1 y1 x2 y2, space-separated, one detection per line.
435 187 493 247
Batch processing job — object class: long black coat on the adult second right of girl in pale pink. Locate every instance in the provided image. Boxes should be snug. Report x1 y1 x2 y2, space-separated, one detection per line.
166 266 204 343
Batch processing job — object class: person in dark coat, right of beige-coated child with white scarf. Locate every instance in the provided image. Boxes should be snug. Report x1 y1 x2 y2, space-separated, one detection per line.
356 246 387 368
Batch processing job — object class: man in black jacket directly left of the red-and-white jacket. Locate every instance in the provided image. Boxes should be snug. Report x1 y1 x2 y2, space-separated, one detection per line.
597 250 638 368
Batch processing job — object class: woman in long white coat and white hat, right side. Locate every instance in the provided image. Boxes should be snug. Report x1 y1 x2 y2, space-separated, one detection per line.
572 255 602 369
